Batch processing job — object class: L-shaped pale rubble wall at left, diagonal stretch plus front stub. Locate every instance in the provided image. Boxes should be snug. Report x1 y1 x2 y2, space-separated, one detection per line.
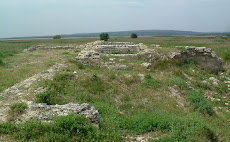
0 64 100 122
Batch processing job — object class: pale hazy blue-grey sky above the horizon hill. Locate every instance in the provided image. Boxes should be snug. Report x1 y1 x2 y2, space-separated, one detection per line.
0 0 230 38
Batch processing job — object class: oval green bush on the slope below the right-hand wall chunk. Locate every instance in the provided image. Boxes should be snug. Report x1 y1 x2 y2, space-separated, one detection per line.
187 91 214 115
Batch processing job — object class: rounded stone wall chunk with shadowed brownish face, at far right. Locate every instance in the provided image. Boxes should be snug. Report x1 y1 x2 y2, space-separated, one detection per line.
172 46 222 73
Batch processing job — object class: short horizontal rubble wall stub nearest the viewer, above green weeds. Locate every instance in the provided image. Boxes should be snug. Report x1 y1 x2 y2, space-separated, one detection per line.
22 102 100 122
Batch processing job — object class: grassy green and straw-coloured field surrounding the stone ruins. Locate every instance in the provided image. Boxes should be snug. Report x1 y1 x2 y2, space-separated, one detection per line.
0 37 230 142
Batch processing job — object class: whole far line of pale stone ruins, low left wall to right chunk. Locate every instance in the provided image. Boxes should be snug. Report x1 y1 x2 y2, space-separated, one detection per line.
24 41 222 73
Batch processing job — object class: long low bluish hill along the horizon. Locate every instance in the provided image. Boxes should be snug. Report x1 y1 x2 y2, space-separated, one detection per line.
2 30 230 40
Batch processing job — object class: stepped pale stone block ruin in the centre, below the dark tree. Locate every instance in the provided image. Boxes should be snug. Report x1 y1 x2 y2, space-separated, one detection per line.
76 41 149 69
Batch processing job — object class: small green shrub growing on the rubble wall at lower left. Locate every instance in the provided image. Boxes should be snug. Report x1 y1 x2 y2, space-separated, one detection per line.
9 103 28 115
